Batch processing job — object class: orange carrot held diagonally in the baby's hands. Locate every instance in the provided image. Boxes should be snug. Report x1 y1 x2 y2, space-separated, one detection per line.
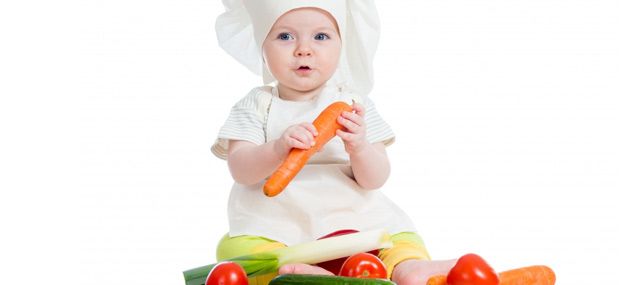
264 102 352 197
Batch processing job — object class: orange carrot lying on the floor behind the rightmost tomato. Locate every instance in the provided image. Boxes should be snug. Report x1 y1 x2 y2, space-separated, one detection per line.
427 265 556 285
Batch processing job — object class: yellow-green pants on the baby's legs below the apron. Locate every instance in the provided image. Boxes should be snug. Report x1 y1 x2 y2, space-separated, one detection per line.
217 232 430 285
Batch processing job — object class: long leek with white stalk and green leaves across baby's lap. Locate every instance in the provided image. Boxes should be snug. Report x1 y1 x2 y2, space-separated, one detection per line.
184 230 392 285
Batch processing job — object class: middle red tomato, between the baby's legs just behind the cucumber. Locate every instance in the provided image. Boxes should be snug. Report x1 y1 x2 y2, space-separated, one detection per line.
339 252 388 279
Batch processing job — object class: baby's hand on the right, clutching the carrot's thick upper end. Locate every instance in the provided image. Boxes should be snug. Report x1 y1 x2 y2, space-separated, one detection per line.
337 103 368 155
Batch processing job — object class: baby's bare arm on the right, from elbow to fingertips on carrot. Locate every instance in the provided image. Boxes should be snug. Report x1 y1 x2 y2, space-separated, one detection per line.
337 103 390 189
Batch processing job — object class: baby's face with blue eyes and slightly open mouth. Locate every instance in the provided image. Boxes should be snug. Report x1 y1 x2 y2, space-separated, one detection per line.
263 8 341 92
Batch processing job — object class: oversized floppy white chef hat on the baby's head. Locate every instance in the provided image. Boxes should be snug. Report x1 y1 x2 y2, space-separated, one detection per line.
215 0 379 95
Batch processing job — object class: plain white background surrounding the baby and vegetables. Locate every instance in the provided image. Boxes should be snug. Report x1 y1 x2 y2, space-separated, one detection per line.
0 0 638 284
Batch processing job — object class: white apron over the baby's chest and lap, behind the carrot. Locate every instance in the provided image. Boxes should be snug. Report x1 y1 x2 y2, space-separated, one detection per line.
228 87 415 245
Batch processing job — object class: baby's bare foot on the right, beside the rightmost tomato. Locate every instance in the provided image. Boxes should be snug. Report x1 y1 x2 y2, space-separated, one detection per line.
392 259 456 285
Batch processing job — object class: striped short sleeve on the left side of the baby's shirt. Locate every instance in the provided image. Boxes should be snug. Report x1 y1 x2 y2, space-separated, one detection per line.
211 88 270 159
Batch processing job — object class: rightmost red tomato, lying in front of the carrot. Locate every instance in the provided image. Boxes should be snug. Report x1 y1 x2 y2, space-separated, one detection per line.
447 253 499 285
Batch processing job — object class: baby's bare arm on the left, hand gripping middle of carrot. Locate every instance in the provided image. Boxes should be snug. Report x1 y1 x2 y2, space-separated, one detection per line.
228 123 317 185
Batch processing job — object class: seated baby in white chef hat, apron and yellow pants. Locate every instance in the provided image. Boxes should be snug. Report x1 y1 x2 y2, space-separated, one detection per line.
212 0 455 285
